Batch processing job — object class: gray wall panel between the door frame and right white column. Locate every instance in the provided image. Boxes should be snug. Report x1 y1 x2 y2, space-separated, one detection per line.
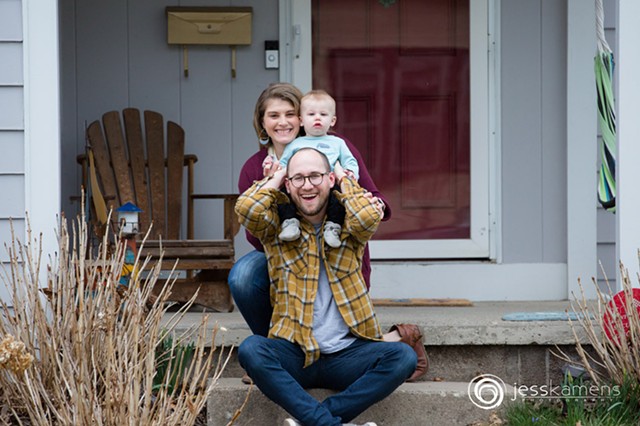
500 0 567 263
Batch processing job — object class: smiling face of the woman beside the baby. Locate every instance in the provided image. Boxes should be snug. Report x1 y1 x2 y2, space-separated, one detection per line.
262 99 300 149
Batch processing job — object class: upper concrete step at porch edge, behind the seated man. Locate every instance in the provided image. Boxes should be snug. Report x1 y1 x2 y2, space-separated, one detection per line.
170 301 582 385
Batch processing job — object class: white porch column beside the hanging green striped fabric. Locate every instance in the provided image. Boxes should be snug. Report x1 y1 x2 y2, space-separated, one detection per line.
567 0 600 299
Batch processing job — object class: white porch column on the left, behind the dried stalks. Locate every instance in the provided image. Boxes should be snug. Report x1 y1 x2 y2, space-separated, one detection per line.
22 0 60 272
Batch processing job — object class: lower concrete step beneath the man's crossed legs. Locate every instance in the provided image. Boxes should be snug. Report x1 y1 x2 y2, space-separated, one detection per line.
207 378 514 426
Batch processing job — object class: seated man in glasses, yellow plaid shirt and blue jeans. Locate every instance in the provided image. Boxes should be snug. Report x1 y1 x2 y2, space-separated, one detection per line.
236 148 417 426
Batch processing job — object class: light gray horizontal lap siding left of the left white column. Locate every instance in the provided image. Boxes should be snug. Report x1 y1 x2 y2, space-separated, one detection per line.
0 0 25 301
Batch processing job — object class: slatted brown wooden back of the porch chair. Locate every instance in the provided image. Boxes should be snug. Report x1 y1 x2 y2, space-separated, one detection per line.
87 108 185 240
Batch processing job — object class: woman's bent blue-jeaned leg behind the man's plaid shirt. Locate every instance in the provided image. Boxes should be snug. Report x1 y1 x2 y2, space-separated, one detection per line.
229 250 273 337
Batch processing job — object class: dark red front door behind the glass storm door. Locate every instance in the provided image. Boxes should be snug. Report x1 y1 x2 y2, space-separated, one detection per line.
312 0 471 240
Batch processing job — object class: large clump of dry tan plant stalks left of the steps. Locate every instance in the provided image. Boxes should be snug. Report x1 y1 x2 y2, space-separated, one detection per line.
0 211 230 426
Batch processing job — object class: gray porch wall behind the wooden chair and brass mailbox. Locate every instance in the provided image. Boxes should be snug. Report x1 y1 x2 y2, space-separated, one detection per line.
60 0 279 253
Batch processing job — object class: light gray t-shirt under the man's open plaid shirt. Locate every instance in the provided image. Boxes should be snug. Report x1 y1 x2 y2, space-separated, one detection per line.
313 225 356 354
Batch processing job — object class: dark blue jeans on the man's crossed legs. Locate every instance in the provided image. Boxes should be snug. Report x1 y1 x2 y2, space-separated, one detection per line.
238 335 417 426
